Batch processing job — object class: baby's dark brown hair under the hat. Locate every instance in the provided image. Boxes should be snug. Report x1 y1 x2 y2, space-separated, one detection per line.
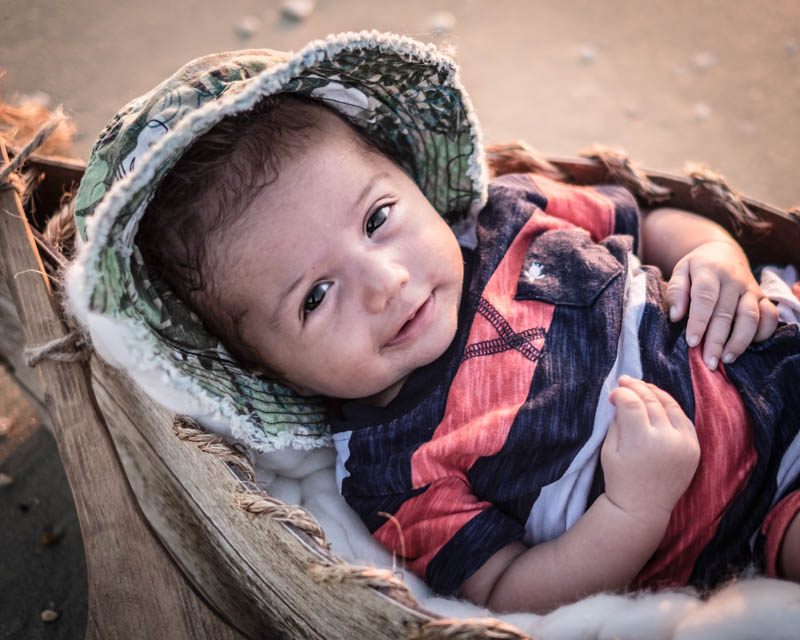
136 94 399 379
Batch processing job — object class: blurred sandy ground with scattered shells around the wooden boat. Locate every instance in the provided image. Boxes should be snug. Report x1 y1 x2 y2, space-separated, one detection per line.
0 0 800 638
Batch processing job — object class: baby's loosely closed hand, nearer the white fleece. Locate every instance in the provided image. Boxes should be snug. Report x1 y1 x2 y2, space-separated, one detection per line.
600 376 700 523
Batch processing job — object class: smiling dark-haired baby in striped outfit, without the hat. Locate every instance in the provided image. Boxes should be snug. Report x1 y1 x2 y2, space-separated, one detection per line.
72 35 800 611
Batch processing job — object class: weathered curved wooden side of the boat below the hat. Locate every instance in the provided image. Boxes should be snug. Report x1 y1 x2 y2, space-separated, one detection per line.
92 360 430 640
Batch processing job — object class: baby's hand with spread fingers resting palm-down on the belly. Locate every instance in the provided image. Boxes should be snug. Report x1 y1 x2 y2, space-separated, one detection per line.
666 240 778 369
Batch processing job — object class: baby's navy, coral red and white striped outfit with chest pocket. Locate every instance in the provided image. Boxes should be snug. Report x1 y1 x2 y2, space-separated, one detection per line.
333 174 800 595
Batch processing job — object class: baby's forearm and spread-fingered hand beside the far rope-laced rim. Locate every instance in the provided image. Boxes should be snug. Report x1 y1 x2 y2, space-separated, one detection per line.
641 209 778 369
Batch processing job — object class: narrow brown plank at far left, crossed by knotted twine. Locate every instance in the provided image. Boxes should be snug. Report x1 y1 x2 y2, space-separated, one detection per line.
0 150 240 640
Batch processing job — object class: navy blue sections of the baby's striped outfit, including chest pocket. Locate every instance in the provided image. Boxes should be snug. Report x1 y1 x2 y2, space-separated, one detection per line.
333 176 800 595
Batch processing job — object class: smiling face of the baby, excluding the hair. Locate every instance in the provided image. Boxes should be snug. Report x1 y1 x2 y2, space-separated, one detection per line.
218 107 464 404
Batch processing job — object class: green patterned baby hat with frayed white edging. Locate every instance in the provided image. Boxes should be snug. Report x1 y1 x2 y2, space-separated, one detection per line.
67 32 487 451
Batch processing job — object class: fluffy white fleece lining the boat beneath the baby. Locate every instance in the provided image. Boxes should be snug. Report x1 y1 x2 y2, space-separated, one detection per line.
254 449 800 640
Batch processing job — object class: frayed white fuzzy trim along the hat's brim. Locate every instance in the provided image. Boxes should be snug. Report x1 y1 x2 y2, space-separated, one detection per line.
65 31 488 452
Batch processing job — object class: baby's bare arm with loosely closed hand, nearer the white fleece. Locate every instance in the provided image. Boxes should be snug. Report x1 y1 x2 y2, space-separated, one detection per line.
461 377 700 611
